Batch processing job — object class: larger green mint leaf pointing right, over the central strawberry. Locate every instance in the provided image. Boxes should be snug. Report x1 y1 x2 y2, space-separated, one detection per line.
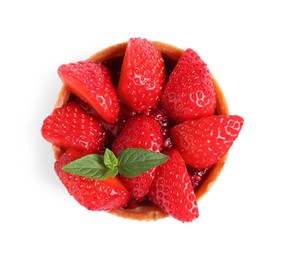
118 148 169 178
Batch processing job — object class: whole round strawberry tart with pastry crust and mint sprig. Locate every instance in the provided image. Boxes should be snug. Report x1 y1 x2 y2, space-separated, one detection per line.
41 38 243 222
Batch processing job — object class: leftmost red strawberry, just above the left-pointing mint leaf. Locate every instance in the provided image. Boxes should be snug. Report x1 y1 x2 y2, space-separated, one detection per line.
41 102 105 153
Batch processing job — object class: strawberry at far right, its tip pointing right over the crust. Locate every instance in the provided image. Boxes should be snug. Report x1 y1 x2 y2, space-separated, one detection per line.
171 115 243 168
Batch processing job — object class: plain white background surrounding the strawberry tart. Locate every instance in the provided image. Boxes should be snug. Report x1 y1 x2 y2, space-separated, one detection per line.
0 0 285 260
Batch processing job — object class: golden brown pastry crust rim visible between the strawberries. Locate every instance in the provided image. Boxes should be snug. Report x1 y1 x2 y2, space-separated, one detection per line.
53 42 229 221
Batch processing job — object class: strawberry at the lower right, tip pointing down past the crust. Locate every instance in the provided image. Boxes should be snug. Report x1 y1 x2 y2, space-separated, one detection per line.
148 149 199 222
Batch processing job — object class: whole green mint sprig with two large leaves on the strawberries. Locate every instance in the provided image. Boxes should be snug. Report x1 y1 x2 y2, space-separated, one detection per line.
62 148 169 180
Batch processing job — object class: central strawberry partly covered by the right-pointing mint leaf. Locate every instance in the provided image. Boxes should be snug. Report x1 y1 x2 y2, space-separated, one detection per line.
112 115 163 199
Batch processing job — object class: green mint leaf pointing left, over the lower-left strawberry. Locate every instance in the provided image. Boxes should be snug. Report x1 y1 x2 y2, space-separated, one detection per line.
62 154 110 180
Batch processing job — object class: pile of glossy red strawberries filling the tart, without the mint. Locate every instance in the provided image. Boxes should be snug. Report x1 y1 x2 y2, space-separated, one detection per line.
41 38 243 222
